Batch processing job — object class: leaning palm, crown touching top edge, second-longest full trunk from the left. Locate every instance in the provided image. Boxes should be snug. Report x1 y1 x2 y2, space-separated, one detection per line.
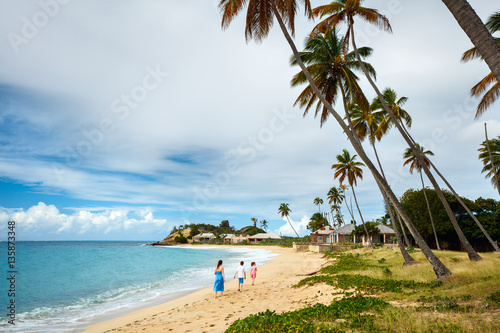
313 0 482 260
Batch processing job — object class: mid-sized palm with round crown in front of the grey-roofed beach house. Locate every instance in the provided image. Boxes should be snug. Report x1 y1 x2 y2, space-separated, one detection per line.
332 149 375 249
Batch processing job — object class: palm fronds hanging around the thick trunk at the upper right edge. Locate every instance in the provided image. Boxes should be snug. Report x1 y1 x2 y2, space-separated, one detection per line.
462 11 500 118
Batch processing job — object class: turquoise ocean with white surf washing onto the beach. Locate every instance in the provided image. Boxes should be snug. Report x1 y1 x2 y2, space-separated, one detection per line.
0 241 278 333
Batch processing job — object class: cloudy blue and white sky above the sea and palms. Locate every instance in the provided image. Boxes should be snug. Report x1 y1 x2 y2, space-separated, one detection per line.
0 0 500 241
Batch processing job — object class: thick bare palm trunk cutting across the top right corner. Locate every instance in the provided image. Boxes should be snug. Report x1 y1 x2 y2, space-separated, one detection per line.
442 0 500 82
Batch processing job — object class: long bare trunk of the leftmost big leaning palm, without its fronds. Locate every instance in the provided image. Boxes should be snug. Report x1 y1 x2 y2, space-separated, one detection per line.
271 2 452 280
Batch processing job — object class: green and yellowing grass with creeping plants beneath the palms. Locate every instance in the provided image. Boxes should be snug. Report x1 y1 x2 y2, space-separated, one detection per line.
226 247 500 333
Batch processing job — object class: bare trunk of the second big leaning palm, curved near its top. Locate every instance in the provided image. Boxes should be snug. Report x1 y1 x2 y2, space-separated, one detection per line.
349 18 482 260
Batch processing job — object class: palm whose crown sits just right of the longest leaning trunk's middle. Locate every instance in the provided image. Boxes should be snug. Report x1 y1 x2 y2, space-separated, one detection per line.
349 101 415 266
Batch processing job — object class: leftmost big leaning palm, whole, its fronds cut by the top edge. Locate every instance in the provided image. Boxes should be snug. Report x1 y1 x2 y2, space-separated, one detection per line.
219 0 451 279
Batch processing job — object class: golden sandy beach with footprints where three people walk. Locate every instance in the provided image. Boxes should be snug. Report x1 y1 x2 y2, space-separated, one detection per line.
84 246 334 333
